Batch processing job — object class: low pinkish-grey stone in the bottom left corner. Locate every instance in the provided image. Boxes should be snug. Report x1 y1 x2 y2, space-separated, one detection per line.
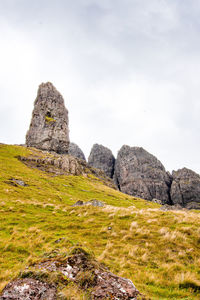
0 278 57 300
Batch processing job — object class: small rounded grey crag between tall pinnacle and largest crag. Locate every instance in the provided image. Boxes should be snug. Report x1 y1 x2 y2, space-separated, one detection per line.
88 144 115 178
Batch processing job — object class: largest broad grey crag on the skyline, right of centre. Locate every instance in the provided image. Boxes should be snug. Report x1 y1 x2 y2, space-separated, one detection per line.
114 145 171 204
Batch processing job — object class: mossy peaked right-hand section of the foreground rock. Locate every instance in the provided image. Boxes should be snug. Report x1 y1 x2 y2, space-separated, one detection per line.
28 248 140 300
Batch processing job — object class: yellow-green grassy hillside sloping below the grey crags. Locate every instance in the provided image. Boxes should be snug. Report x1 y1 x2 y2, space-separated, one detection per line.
0 145 200 300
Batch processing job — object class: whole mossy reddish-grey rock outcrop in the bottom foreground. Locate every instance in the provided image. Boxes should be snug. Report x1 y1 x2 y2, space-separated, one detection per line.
0 248 141 300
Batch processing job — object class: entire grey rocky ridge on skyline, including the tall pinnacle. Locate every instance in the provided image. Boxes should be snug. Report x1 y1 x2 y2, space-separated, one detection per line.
25 82 200 208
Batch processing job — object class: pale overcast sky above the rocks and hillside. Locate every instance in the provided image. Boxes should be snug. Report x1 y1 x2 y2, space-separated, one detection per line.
0 0 200 173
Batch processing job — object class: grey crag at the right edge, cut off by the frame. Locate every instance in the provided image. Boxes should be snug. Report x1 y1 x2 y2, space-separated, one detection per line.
171 168 200 209
